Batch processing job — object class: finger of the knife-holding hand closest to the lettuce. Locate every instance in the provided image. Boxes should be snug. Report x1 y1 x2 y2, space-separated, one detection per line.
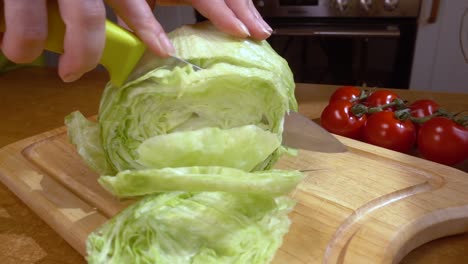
107 0 175 57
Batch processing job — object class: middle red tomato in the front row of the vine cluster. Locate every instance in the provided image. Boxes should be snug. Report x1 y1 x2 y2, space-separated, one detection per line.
363 111 416 152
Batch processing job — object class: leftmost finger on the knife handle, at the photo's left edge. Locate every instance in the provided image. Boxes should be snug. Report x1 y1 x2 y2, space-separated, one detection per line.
1 0 47 63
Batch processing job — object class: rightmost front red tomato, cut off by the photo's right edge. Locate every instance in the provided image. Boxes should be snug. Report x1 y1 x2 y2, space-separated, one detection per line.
418 117 468 165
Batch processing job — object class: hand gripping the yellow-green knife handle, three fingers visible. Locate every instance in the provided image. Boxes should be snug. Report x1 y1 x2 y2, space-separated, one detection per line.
0 0 174 82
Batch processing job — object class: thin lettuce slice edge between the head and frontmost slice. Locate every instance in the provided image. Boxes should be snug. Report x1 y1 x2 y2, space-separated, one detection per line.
99 167 302 197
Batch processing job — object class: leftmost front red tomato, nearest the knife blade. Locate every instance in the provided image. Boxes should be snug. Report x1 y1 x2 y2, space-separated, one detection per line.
321 100 367 139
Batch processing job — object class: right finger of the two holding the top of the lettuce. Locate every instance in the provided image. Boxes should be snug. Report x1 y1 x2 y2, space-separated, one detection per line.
226 0 273 40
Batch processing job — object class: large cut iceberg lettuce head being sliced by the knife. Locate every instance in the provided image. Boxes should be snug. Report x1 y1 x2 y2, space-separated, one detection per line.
67 23 297 175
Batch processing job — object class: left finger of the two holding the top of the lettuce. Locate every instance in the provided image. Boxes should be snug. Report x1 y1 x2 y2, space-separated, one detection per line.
191 0 250 38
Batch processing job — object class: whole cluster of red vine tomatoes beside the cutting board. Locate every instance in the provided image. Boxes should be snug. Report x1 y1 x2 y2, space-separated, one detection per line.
321 86 468 165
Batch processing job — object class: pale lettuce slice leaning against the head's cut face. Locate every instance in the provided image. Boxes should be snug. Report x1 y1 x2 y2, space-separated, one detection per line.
137 125 281 171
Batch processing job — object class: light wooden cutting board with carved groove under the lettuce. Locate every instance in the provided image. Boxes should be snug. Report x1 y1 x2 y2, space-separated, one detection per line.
0 125 468 264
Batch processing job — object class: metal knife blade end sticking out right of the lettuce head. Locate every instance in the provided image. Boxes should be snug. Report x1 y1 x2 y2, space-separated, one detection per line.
283 112 347 153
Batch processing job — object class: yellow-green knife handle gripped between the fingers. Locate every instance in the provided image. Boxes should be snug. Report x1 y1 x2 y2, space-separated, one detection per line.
0 1 146 86
